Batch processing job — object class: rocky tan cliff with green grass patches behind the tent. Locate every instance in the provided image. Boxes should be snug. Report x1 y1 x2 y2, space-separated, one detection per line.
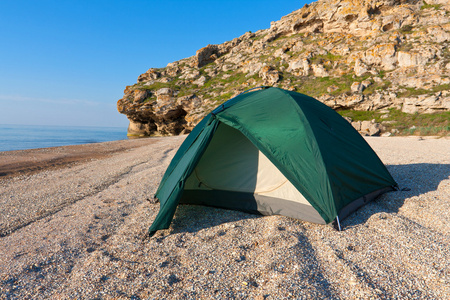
117 0 450 135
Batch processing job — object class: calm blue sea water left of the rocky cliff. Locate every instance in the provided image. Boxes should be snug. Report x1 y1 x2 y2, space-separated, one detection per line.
0 125 127 151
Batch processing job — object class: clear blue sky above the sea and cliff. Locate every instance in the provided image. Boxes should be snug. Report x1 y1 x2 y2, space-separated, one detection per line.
0 0 311 127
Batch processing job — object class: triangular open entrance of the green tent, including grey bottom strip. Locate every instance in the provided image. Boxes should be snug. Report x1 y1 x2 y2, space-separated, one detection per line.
180 123 325 224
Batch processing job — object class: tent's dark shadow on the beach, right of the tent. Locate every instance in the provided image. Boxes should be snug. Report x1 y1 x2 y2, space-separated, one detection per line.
341 163 450 230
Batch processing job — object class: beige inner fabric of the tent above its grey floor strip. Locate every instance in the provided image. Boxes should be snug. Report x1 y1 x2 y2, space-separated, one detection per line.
185 124 311 206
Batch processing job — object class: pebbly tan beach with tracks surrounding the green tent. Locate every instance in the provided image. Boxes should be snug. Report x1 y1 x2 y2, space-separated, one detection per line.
0 136 450 300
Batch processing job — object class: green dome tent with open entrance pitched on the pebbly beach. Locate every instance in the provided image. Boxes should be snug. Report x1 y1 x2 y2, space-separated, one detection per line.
149 88 397 235
